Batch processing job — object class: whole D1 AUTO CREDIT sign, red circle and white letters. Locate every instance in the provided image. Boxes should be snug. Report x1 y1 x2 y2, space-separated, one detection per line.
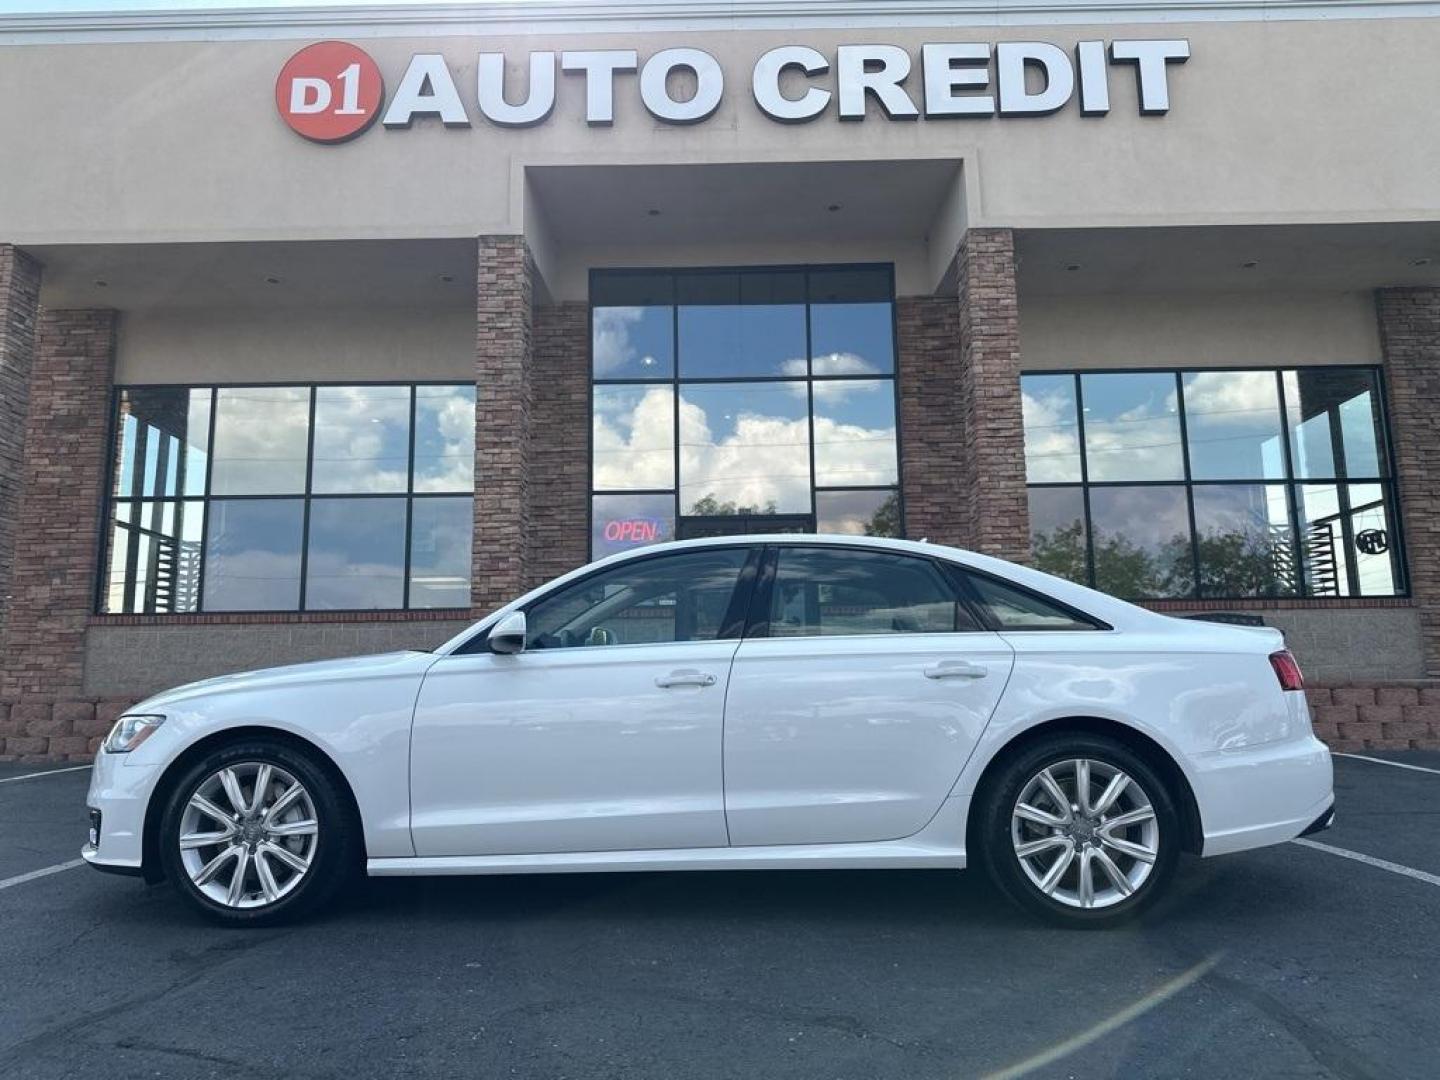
275 39 1189 143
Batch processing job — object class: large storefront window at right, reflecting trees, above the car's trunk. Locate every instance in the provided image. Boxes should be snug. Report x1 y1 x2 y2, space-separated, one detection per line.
1021 367 1404 599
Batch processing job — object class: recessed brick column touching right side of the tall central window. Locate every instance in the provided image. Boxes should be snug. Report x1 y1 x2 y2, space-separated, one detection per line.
896 297 969 544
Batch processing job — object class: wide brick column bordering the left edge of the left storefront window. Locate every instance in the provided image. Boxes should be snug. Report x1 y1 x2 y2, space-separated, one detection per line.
0 311 115 705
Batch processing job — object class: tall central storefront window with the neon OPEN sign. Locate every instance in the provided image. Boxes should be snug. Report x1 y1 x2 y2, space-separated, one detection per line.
590 266 900 557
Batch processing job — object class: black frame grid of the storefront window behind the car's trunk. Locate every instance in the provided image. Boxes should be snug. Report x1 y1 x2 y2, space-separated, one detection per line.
1020 363 1411 603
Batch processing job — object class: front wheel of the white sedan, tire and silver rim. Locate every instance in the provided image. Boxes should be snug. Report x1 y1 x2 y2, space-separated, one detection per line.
160 739 359 926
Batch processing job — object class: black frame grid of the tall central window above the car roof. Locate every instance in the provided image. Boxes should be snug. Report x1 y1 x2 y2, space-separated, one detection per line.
585 262 904 559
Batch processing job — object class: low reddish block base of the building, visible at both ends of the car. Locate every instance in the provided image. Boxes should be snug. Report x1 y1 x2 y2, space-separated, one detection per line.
11 680 1440 765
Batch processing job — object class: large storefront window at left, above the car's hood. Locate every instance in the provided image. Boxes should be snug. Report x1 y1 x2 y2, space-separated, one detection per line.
99 384 475 613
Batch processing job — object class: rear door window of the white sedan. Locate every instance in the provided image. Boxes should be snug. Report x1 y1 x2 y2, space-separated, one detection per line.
769 547 981 638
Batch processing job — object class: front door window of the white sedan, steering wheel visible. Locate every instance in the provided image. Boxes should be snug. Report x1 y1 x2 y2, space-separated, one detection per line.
526 547 750 649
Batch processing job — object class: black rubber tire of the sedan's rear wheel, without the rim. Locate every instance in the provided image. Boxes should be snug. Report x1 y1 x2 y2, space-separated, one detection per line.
972 732 1184 929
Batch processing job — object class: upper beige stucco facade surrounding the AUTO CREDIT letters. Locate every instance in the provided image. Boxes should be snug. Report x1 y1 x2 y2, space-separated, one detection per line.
0 19 1440 243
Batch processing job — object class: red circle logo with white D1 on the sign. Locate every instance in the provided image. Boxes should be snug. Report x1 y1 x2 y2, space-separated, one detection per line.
275 42 384 143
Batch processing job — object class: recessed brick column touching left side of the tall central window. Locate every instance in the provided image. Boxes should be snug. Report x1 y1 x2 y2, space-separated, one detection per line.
527 302 590 586
